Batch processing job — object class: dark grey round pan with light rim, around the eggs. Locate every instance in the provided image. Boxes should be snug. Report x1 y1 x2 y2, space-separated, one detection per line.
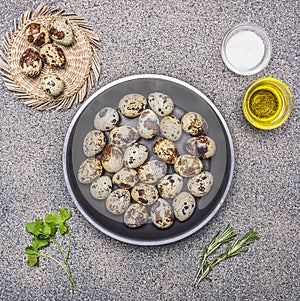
63 74 234 246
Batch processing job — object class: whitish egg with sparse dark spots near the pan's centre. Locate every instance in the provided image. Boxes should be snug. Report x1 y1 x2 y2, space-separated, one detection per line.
124 143 148 168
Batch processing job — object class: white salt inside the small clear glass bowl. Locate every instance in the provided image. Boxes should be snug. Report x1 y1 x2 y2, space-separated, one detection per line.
225 30 265 71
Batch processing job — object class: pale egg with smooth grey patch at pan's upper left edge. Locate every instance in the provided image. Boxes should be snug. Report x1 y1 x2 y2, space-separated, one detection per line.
94 107 120 131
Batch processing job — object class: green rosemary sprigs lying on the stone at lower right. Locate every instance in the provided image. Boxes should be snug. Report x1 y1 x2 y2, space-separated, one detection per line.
194 225 259 286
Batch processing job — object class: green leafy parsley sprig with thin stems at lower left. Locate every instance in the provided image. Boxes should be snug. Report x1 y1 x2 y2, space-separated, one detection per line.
25 207 75 295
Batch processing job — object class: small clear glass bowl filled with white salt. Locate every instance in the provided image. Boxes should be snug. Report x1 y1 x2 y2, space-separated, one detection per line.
221 23 272 75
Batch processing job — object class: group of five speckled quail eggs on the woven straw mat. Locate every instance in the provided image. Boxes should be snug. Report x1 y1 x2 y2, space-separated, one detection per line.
20 17 74 97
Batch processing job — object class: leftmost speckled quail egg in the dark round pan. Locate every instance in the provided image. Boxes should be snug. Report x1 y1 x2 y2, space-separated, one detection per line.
78 158 103 184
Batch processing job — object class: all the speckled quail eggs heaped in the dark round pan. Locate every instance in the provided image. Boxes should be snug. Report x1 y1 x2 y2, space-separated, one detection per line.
78 92 216 229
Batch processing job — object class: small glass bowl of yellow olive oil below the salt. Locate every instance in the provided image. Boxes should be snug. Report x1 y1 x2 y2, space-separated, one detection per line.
242 77 293 130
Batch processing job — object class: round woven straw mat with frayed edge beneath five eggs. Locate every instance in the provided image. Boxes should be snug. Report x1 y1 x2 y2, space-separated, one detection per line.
0 5 101 110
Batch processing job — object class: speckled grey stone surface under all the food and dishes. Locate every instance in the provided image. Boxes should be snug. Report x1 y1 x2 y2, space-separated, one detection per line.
0 0 300 301
